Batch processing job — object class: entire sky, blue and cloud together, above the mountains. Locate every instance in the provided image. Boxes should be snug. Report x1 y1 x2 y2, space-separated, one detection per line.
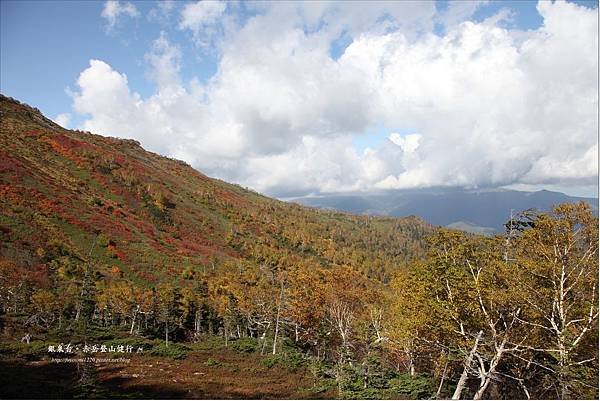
0 0 598 198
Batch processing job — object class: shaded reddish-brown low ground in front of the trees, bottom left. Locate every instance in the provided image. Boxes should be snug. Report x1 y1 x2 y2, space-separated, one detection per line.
0 349 336 399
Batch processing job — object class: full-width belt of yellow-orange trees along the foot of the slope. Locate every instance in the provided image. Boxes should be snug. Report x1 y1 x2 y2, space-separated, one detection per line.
1 204 598 399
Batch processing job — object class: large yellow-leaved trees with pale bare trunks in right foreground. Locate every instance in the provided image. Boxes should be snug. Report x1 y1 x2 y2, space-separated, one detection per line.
390 203 598 399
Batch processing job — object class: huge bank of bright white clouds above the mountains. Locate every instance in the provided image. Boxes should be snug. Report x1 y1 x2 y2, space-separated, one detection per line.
73 1 598 195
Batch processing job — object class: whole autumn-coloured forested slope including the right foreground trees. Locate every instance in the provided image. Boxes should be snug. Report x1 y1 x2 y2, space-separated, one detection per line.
0 96 598 399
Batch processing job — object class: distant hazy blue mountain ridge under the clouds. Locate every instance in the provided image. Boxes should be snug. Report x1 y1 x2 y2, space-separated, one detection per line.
293 188 598 234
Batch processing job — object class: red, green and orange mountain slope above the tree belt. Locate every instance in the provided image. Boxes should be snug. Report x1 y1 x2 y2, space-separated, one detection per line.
0 96 432 286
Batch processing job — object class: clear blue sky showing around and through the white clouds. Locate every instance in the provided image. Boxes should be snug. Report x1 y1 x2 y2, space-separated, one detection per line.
0 0 597 134
